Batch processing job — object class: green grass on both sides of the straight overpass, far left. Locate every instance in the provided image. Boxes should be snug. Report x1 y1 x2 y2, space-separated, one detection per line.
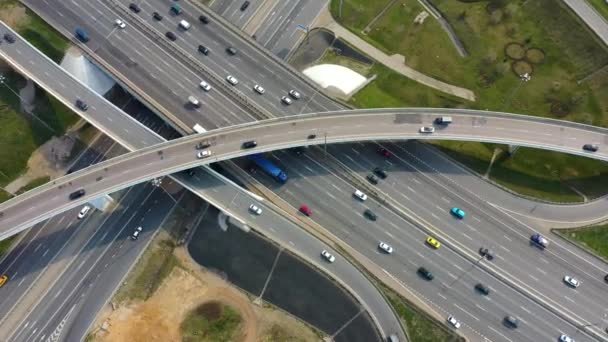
0 1 78 186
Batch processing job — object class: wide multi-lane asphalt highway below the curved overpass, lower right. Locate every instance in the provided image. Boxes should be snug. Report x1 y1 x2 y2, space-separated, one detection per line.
241 148 603 341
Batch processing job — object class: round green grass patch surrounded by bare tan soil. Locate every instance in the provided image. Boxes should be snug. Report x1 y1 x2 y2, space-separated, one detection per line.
180 302 242 342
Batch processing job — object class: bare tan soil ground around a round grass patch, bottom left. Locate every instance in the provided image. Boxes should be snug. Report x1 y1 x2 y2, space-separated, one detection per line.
92 247 321 342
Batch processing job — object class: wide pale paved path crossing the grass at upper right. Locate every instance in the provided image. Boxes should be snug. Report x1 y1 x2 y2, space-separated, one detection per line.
313 8 475 101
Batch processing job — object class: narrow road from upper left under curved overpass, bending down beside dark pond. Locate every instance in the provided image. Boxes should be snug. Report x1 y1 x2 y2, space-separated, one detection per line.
3 21 401 335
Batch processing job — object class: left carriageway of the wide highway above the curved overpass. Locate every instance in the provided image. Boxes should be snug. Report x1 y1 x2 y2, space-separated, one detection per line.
57 2 250 128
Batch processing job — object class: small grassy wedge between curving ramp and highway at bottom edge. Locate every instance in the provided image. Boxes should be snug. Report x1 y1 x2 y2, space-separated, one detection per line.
381 285 464 342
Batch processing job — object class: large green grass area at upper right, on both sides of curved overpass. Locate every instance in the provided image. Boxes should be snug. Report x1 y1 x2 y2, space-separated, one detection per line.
331 0 608 202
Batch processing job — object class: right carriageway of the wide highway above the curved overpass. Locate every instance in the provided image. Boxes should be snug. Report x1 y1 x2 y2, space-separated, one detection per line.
124 0 320 115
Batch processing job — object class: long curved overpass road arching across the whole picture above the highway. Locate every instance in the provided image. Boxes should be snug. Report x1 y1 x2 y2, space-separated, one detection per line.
0 109 608 238
